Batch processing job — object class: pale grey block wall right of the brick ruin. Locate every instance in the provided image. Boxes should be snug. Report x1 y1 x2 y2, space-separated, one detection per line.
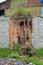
32 17 43 48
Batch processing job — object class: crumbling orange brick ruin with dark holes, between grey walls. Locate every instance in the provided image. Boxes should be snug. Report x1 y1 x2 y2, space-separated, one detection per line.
9 14 33 46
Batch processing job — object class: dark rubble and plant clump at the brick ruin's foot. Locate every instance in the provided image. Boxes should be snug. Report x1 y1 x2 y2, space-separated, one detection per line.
21 47 36 57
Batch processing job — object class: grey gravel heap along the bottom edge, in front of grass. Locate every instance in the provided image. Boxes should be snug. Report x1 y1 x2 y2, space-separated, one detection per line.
0 59 35 65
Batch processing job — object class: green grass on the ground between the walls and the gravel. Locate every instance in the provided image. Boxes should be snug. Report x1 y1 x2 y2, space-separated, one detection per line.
0 47 43 65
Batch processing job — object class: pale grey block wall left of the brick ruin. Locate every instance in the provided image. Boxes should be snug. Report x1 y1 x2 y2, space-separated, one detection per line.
0 17 9 47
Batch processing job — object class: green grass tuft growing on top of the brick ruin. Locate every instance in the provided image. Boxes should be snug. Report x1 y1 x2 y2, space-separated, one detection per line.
6 7 31 17
